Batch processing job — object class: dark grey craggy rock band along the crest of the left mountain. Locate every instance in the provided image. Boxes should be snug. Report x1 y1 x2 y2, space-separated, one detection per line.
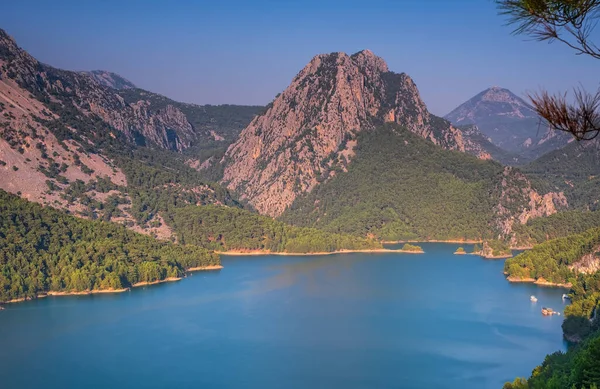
0 30 194 150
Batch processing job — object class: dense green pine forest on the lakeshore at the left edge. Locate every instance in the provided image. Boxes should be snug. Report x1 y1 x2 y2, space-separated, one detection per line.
0 191 219 301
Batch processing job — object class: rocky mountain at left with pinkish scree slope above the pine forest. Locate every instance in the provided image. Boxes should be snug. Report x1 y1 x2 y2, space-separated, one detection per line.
0 30 248 239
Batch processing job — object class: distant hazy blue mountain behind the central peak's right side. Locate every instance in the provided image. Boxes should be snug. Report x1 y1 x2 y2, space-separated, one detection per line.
444 87 571 164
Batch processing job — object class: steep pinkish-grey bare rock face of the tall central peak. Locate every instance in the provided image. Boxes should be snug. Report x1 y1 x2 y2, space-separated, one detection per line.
223 50 464 216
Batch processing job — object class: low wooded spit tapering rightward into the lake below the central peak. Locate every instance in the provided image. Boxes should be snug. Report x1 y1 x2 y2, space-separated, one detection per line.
167 206 381 253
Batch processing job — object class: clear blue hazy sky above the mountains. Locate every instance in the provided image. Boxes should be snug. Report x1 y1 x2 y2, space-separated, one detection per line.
0 0 600 115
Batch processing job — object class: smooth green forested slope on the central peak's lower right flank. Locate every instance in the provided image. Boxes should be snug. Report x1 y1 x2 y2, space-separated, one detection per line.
281 125 510 241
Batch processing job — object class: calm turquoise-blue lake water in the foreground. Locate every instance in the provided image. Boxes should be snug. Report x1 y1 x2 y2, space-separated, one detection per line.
0 244 565 389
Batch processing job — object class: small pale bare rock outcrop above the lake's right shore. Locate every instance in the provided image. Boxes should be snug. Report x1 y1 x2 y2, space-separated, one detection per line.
494 167 568 237
